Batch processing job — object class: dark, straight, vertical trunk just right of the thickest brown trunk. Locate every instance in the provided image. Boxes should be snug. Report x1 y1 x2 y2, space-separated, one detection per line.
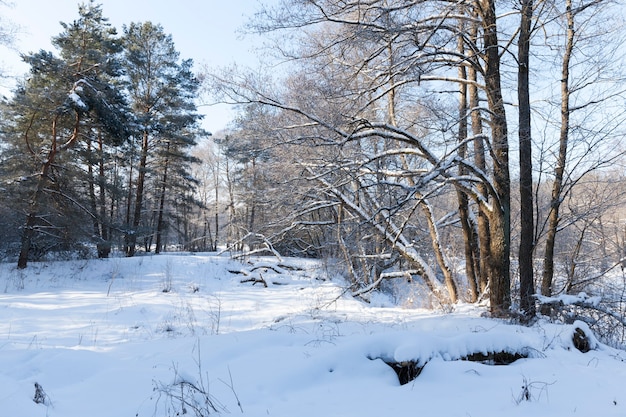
517 0 535 319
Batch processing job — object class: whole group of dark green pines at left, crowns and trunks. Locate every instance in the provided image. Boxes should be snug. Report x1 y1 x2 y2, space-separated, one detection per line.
0 0 205 267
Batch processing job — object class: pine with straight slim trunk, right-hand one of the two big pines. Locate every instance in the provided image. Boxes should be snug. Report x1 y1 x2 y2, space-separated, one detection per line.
124 22 203 256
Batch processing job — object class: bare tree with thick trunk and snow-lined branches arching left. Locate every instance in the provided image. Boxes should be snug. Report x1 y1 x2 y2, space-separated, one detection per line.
208 1 510 315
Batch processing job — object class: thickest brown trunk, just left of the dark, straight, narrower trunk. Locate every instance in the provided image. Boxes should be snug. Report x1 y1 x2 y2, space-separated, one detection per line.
478 0 511 316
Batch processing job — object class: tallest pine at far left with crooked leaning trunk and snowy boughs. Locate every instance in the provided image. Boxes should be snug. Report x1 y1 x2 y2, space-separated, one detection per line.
10 0 128 268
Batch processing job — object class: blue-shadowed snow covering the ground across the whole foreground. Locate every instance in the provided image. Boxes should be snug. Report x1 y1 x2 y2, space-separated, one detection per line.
0 254 626 417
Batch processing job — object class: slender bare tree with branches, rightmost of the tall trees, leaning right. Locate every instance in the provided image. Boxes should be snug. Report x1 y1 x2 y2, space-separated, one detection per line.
541 0 623 306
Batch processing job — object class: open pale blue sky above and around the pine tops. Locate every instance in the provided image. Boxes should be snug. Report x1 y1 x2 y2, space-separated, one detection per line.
0 0 266 133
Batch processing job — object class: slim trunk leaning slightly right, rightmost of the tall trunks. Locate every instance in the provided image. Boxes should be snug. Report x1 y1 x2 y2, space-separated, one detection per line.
541 0 574 302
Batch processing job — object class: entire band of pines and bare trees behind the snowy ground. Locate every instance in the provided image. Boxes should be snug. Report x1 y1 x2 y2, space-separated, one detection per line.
0 0 626 334
